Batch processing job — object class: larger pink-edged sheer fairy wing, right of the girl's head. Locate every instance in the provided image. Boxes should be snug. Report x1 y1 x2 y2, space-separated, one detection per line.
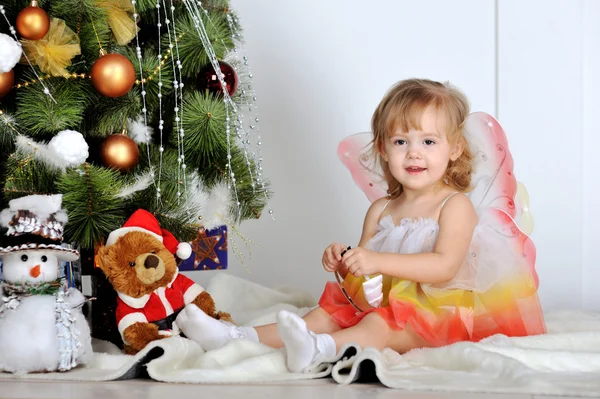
465 112 539 287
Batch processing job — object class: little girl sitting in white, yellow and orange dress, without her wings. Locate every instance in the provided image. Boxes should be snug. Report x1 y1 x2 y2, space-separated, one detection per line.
177 79 545 372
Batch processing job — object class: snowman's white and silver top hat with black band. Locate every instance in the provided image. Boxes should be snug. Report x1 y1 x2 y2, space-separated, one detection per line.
0 194 79 261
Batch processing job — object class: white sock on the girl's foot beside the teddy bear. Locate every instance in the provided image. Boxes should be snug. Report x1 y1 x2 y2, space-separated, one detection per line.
175 304 259 351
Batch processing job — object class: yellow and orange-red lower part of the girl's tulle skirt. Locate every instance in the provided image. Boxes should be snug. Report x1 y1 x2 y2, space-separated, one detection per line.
319 273 546 346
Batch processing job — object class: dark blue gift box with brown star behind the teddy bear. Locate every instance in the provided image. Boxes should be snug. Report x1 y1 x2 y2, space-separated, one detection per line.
179 225 227 271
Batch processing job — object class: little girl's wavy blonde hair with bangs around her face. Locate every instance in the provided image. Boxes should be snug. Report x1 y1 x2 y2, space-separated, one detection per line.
371 79 473 199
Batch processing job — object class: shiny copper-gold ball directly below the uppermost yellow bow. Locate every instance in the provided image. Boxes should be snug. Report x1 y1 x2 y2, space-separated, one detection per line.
91 52 135 97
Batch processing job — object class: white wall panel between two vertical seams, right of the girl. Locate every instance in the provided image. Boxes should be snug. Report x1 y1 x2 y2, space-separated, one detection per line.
498 0 591 307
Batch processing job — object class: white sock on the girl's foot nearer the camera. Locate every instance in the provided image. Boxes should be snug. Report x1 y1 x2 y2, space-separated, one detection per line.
277 310 336 373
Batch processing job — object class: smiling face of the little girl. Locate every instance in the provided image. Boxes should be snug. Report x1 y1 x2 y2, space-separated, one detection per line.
382 107 462 191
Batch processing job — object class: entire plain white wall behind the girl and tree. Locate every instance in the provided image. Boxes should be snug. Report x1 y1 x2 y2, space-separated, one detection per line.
193 0 600 308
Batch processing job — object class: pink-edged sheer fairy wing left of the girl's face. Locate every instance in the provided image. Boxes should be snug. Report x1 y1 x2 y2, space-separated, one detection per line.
337 132 387 202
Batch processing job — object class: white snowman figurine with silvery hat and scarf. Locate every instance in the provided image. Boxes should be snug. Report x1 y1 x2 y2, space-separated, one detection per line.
0 194 92 374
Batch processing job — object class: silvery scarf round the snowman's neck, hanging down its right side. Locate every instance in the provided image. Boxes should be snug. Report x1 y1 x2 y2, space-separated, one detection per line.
0 279 81 371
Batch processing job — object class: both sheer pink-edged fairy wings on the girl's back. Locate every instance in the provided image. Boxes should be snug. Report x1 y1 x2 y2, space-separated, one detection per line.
338 112 538 286
